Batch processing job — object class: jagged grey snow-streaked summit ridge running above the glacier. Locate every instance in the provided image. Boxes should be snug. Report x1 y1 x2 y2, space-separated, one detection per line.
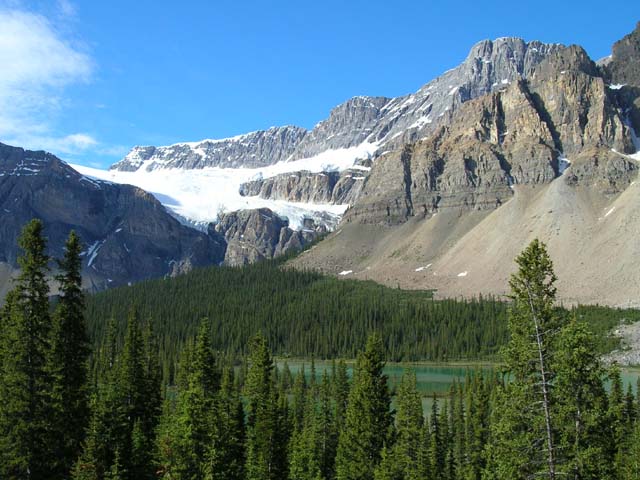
111 37 564 175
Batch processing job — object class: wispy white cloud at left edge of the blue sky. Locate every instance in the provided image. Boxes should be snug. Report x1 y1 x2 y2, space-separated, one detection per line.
0 7 98 154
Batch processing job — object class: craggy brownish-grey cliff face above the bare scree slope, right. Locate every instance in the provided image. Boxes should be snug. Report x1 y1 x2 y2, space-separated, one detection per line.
345 42 637 224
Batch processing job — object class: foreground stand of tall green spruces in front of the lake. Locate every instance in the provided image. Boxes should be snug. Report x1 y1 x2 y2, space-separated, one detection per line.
0 221 640 480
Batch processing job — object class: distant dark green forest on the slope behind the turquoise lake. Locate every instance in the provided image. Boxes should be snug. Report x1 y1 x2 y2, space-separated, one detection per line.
87 261 640 382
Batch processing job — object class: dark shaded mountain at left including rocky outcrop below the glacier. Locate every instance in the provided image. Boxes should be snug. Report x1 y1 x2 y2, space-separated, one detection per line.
0 144 323 293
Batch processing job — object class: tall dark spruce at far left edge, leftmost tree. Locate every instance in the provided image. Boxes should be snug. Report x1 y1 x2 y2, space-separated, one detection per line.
0 220 55 479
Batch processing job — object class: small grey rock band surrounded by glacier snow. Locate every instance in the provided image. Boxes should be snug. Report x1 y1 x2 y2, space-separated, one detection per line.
240 169 366 205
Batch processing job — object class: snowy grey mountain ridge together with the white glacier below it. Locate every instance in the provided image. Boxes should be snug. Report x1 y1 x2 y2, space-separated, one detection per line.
94 38 562 234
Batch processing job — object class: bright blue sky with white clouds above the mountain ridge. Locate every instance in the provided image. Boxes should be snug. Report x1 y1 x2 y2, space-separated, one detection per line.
0 0 640 166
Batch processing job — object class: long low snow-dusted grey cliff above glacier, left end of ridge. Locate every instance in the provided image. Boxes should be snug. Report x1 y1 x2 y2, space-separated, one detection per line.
111 126 307 171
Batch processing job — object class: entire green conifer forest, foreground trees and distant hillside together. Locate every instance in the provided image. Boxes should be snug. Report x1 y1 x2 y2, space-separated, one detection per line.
0 220 640 480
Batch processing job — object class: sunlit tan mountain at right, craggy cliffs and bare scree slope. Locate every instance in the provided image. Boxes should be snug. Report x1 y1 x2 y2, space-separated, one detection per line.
295 24 640 305
